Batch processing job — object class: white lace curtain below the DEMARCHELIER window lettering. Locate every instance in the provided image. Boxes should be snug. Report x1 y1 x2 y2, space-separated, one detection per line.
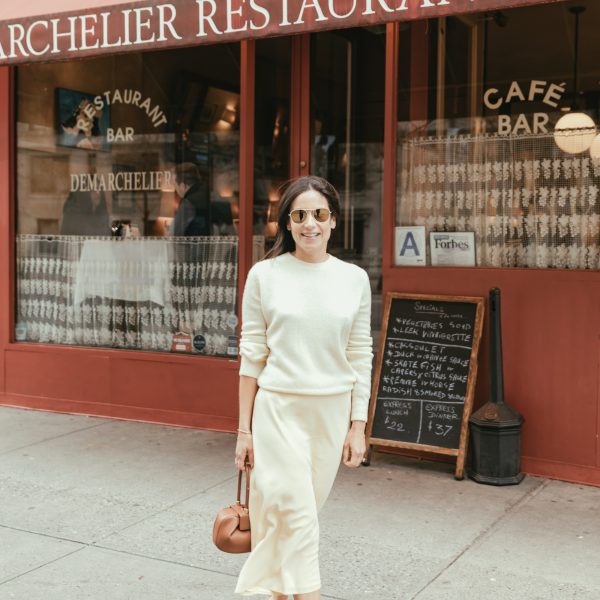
16 235 238 356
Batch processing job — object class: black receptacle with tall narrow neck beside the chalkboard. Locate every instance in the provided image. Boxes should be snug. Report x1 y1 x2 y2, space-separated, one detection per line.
467 288 524 485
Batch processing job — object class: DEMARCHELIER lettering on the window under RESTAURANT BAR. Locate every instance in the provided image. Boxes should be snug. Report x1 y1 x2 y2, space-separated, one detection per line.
71 171 172 192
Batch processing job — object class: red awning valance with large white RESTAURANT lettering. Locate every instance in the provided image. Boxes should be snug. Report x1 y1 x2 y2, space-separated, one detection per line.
0 0 496 63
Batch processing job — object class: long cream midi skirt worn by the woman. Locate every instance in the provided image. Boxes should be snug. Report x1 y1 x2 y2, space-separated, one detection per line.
235 389 350 596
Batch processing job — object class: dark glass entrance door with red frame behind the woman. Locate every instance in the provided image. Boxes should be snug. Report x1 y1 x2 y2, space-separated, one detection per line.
253 26 386 337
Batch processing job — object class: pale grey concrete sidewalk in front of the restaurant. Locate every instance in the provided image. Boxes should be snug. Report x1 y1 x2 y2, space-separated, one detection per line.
0 407 600 600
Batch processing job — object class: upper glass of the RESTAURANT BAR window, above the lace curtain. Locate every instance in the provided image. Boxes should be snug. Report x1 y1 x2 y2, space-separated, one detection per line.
17 44 239 236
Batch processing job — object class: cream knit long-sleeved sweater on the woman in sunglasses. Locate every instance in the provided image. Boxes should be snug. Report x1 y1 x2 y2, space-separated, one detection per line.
240 253 373 421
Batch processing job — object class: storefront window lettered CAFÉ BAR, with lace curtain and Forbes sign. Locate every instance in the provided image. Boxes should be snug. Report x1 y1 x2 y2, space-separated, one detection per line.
396 0 600 269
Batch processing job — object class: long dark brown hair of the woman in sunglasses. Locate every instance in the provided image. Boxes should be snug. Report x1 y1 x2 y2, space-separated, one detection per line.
265 175 340 258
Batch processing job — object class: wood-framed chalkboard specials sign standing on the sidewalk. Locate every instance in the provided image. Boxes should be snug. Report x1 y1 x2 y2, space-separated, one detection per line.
367 293 483 479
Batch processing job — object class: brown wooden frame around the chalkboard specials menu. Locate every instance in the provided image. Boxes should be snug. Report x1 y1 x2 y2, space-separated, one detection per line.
367 292 485 479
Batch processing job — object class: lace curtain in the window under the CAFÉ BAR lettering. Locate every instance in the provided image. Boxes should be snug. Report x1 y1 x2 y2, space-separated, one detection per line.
397 134 600 269
